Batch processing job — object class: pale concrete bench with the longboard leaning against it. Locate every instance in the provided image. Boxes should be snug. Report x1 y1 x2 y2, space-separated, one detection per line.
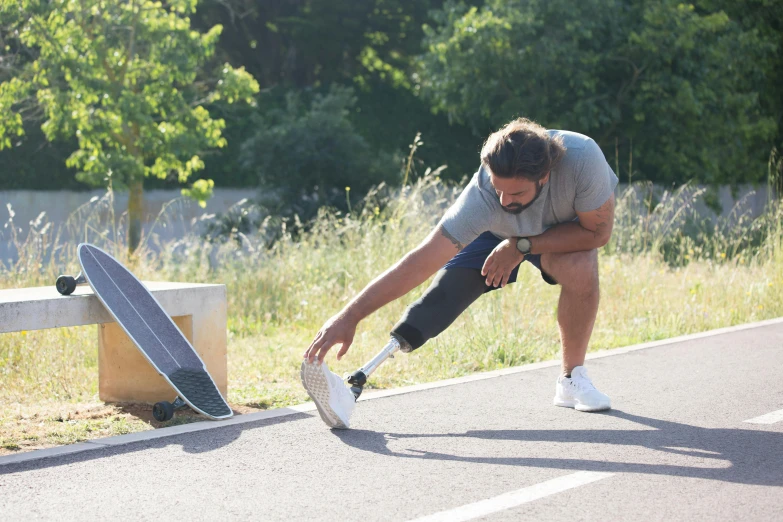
0 281 227 403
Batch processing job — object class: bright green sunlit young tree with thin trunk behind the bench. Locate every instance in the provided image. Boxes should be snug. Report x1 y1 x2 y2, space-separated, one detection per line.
0 0 258 251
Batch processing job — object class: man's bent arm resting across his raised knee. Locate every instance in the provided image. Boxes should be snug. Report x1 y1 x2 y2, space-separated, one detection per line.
530 194 614 254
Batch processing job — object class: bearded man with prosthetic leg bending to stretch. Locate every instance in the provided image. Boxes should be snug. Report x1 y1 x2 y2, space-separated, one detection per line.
302 118 618 428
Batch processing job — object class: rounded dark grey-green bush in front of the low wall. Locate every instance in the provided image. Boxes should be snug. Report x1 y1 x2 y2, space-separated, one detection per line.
240 86 400 218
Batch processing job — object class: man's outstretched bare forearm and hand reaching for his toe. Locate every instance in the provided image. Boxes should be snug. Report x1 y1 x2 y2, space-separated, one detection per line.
304 226 464 362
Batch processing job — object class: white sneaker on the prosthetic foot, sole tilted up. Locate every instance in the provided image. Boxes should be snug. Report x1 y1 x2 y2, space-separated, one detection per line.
299 361 356 429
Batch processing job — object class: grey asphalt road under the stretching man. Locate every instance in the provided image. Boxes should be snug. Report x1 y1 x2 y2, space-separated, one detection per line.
0 323 783 522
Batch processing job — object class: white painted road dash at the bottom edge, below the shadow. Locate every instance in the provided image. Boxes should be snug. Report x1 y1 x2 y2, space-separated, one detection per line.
412 471 613 522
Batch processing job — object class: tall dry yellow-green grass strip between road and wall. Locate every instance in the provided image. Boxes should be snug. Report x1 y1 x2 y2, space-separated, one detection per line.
0 172 783 453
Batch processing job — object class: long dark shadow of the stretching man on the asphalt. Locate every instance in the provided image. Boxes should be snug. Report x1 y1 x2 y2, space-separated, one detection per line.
335 410 783 486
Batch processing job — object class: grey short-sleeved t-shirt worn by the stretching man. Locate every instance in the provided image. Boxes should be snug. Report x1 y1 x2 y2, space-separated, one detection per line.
440 130 618 245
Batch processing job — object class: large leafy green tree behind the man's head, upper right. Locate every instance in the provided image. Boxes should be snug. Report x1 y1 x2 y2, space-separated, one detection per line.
419 0 777 187
